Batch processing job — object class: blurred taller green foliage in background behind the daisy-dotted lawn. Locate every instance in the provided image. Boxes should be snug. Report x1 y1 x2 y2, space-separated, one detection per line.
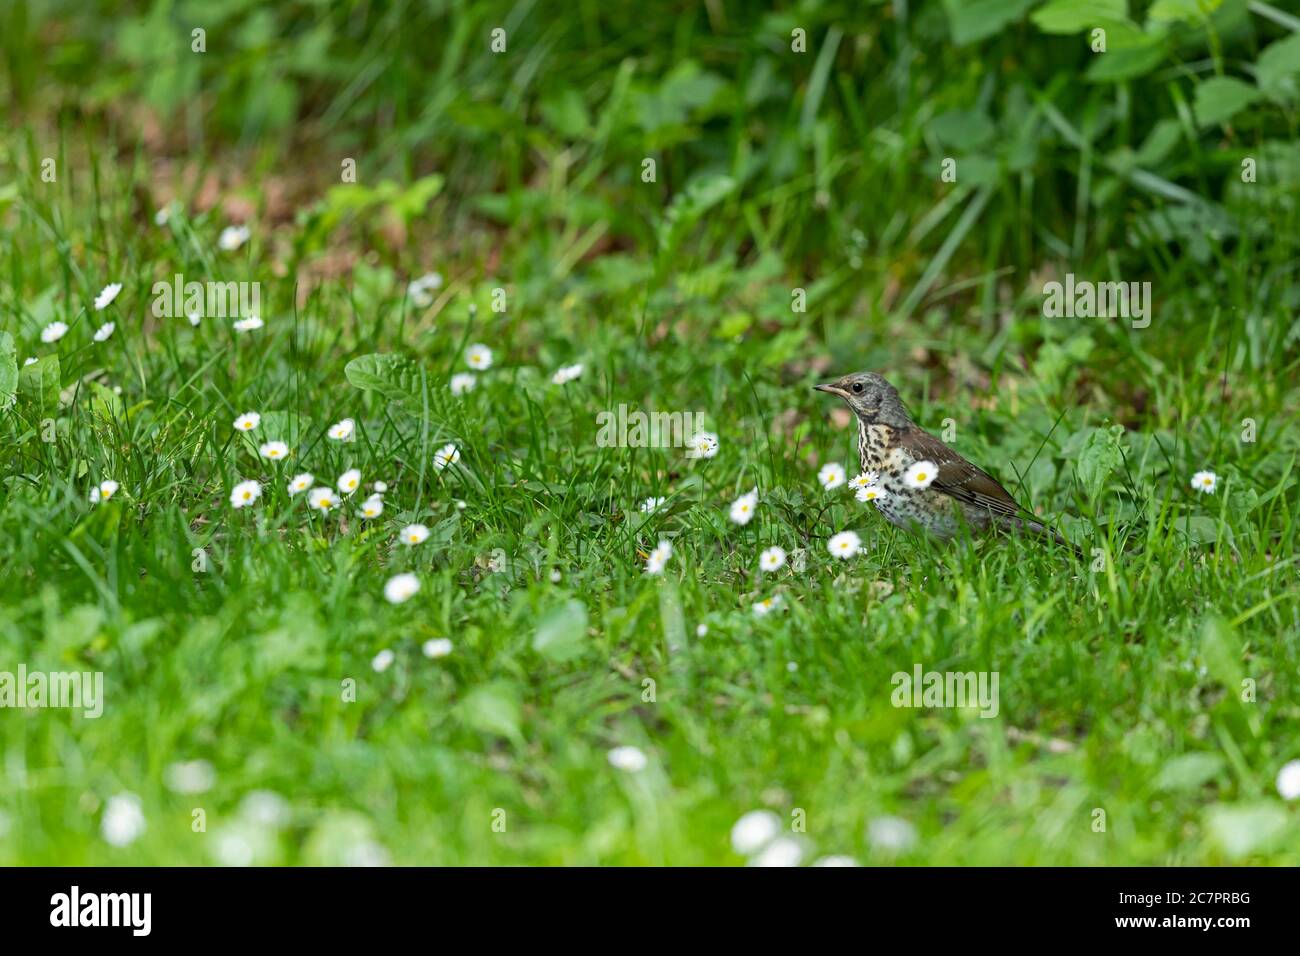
4 0 1300 287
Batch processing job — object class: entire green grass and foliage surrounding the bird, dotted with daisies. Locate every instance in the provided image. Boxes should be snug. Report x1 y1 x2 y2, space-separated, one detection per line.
0 0 1300 865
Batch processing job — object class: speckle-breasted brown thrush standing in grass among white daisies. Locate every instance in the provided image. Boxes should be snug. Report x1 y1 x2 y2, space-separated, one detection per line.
813 372 1082 554
